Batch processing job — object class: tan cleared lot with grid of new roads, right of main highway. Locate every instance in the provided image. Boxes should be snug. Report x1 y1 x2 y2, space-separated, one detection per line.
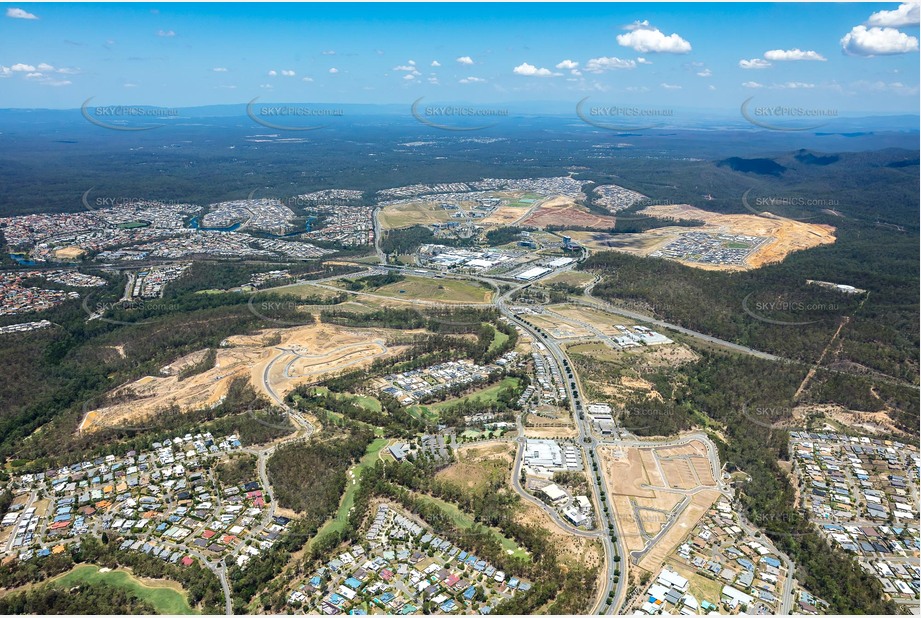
599 440 720 571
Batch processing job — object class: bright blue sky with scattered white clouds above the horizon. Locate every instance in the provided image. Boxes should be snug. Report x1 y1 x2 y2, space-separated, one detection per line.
0 3 919 114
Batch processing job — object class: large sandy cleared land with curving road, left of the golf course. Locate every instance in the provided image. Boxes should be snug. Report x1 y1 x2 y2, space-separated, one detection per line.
80 323 403 432
